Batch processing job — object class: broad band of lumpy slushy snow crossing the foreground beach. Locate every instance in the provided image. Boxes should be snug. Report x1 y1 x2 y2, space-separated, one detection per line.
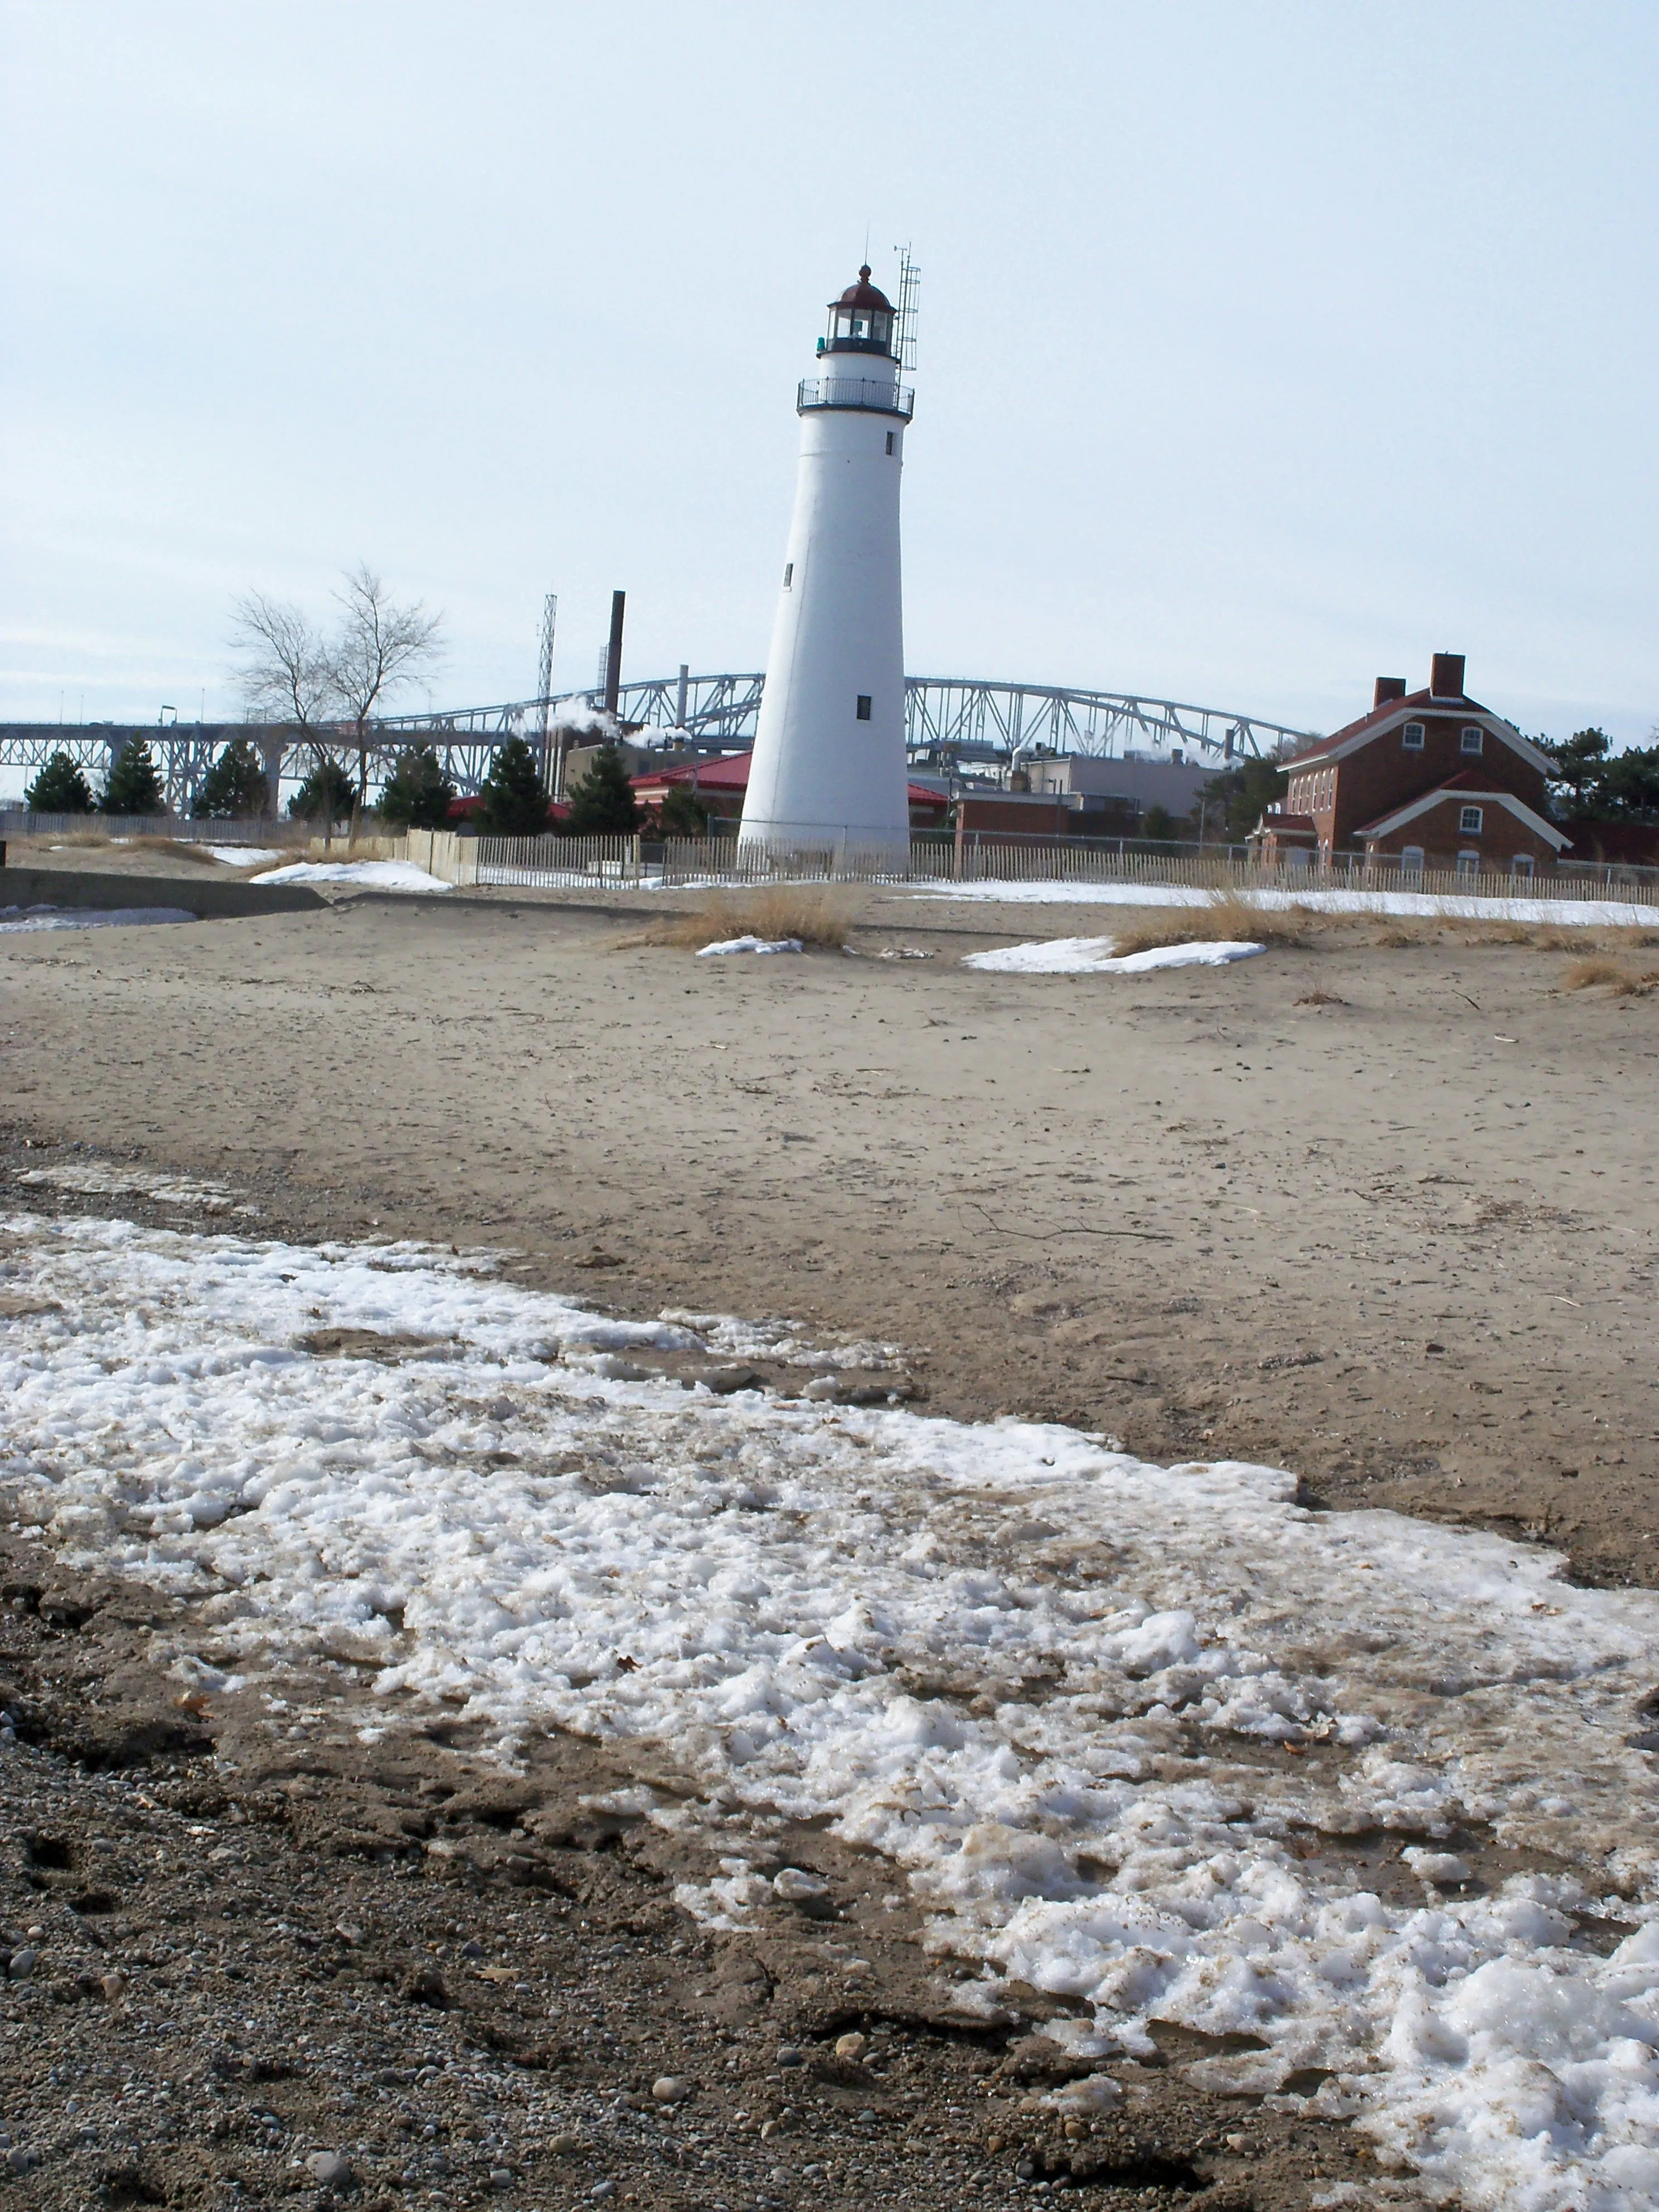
0 1214 1659 2212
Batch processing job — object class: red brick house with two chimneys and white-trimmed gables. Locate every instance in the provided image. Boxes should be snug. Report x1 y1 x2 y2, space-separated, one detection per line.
1252 653 1570 876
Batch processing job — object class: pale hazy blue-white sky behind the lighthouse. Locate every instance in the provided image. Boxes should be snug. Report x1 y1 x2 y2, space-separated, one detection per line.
0 0 1659 760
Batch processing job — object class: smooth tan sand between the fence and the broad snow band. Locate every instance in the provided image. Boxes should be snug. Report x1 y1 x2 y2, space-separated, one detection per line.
0 853 1659 1584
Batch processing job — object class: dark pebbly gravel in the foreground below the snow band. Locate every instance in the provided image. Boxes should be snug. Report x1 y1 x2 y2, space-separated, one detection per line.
0 1535 1389 2212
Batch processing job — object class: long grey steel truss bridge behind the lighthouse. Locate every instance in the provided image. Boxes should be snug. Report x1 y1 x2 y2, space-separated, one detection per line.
0 670 1318 812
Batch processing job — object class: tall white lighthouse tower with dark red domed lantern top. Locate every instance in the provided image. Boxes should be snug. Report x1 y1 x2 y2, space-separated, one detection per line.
741 268 916 847
